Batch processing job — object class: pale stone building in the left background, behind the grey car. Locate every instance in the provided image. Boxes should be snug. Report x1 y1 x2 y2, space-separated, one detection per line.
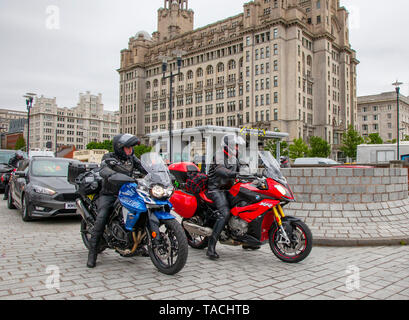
30 92 119 150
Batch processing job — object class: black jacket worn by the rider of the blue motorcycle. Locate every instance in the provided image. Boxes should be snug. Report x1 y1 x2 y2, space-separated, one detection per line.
99 152 147 196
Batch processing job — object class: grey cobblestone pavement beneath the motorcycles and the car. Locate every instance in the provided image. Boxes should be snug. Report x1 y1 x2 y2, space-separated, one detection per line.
0 201 409 300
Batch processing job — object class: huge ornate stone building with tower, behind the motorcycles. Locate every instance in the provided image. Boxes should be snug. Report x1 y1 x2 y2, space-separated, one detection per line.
118 0 359 155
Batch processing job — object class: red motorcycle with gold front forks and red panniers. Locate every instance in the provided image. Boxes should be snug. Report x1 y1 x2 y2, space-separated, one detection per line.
169 151 312 263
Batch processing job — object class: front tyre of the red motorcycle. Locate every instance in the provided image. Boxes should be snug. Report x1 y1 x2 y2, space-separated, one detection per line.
269 221 313 263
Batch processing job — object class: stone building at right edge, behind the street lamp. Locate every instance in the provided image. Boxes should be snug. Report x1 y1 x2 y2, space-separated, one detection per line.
358 91 409 142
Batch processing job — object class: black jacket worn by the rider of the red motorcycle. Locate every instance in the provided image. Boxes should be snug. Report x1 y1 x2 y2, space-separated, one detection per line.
208 152 240 191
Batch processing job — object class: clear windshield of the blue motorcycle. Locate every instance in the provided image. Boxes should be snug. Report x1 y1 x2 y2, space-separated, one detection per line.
141 152 172 188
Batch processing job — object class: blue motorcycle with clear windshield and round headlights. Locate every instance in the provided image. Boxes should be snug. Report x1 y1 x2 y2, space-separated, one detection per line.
68 153 188 275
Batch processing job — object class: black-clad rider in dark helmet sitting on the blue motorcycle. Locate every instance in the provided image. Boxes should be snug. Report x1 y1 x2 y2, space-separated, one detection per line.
87 134 147 268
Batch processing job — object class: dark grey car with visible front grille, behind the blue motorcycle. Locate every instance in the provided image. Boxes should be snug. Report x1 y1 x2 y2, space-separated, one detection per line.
7 157 78 221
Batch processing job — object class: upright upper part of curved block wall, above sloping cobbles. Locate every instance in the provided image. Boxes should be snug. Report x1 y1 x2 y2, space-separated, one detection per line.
282 168 408 203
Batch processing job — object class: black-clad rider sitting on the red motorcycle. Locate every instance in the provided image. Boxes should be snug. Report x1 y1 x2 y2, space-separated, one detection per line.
206 134 246 260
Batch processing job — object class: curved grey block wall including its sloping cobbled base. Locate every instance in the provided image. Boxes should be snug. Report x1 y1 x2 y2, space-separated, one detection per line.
282 168 409 245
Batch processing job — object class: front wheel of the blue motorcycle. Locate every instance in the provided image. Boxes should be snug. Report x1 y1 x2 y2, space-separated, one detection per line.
148 220 188 275
